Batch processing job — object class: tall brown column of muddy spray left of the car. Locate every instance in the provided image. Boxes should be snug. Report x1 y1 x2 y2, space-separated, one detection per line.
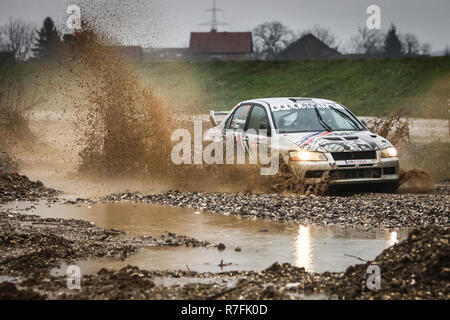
69 29 175 177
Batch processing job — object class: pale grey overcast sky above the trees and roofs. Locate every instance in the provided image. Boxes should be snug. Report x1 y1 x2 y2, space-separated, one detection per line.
0 0 450 52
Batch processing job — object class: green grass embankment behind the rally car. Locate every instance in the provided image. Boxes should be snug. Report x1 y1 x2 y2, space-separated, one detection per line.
0 57 450 118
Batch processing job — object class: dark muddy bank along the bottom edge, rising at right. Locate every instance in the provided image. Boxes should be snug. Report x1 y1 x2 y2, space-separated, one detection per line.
0 222 450 299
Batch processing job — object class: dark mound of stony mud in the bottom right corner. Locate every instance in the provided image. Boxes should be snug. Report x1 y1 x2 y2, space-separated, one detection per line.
326 227 450 300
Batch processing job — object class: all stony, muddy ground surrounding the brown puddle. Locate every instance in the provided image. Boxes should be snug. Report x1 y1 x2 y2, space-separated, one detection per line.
0 159 450 299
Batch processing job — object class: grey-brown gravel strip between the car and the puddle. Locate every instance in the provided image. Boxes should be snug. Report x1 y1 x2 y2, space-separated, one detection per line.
102 184 450 229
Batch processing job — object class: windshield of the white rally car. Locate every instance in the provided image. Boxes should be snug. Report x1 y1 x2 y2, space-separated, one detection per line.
273 106 366 133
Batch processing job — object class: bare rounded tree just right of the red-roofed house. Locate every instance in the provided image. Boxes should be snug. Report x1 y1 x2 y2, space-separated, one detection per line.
253 21 294 59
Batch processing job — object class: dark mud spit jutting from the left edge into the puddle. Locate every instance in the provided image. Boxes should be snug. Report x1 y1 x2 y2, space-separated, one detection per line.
0 210 214 277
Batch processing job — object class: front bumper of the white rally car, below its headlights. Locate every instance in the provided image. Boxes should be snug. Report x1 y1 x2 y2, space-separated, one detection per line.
291 151 400 185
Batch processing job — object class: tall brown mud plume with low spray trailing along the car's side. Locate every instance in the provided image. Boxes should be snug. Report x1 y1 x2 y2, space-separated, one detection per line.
52 26 269 191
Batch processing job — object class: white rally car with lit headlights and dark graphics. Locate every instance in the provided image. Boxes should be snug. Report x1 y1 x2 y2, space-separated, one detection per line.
209 98 399 188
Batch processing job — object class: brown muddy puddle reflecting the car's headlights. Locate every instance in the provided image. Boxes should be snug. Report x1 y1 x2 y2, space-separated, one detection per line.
3 202 407 274
